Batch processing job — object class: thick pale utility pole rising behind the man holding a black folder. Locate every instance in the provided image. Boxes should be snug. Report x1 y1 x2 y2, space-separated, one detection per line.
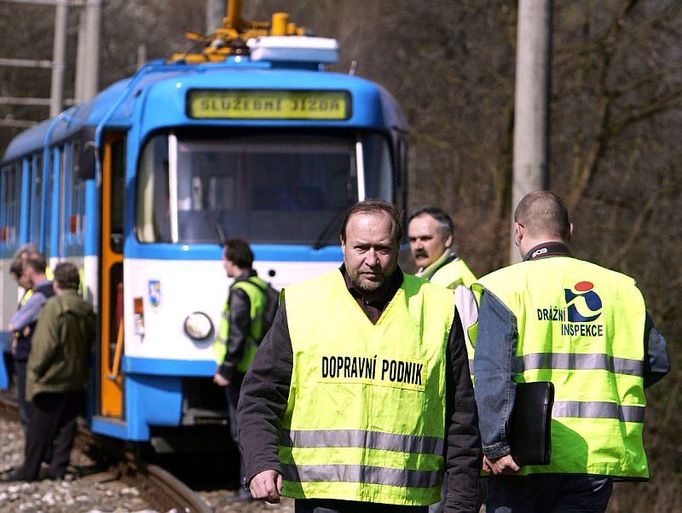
509 0 552 263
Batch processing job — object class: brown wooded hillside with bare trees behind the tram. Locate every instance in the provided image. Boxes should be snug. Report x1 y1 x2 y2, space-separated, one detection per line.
0 0 682 512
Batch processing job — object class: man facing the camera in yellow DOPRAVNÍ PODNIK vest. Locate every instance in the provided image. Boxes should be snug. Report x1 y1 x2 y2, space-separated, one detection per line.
238 200 482 513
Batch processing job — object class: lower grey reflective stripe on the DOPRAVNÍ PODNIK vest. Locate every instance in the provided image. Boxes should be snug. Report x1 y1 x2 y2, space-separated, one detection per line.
282 464 443 488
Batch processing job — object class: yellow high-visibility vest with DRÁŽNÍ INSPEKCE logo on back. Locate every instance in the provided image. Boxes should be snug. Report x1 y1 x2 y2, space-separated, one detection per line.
473 257 649 479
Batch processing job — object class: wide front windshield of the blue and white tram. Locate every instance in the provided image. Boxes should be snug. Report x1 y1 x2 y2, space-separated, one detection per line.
136 132 393 246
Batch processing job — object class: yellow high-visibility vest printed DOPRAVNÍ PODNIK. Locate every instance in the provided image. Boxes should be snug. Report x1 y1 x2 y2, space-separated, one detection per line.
279 270 454 505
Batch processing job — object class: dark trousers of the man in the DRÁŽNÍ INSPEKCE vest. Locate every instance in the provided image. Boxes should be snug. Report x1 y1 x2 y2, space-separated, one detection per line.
486 474 612 513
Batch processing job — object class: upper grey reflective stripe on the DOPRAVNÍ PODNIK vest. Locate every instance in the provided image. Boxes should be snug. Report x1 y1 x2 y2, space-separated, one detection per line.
279 429 443 456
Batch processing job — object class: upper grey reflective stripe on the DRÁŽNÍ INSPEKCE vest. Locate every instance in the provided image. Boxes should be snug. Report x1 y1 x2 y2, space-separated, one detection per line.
514 353 644 376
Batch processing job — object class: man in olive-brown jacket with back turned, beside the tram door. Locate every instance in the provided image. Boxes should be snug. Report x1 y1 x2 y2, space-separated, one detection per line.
3 262 95 481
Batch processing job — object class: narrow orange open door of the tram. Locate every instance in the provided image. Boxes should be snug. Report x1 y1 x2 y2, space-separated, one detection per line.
98 133 126 418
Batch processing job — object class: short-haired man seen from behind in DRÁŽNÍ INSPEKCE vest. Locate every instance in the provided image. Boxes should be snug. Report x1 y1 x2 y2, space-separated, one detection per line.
473 191 670 513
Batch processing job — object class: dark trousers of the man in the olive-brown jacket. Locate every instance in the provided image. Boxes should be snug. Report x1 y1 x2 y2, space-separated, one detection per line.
20 392 84 481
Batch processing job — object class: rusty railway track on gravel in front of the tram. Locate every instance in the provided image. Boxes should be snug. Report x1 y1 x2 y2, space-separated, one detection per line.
0 394 212 513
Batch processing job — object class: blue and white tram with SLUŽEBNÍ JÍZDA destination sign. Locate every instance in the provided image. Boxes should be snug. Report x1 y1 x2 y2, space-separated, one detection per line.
0 20 407 441
